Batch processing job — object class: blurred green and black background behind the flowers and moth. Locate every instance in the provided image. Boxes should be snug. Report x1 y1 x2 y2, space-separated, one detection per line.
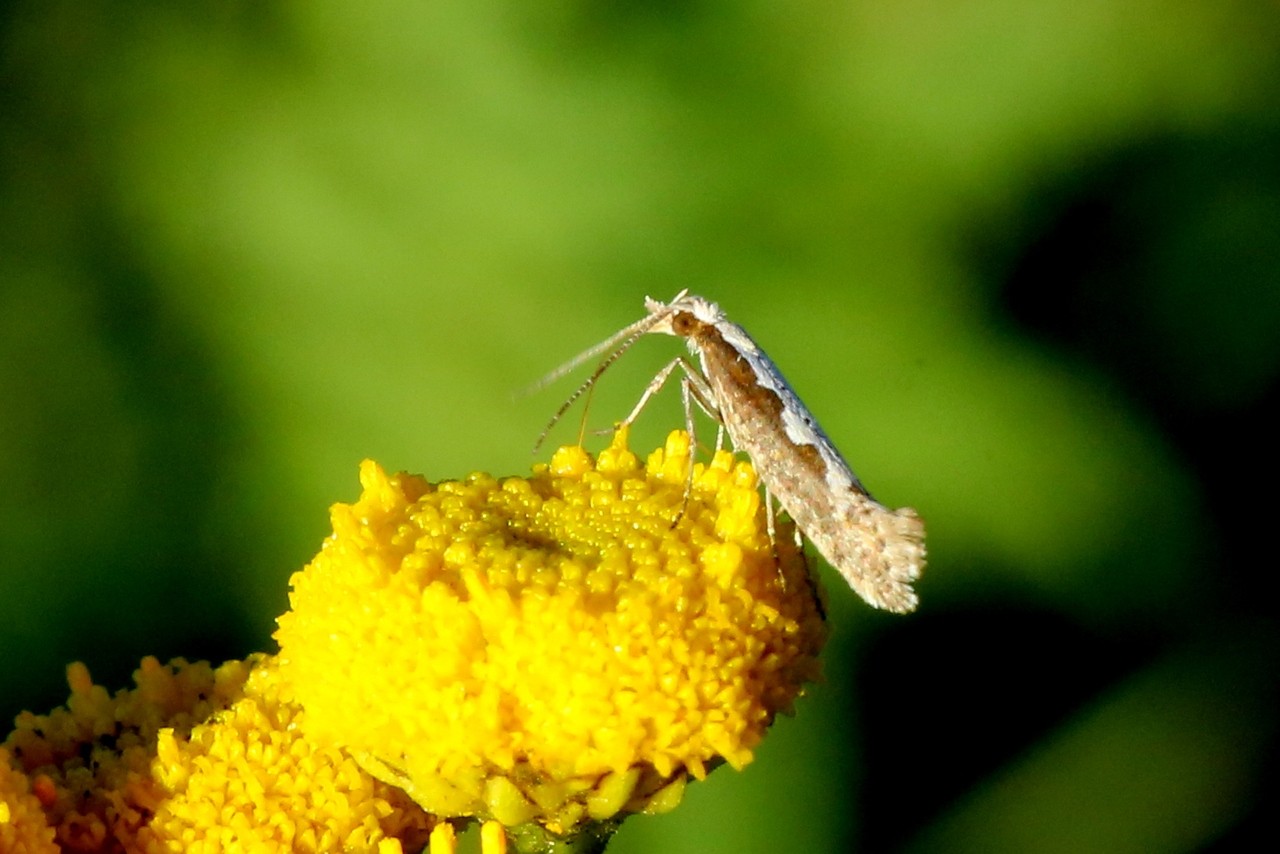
0 0 1280 853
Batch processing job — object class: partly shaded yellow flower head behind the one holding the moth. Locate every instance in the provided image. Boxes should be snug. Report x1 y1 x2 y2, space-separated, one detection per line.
0 656 431 854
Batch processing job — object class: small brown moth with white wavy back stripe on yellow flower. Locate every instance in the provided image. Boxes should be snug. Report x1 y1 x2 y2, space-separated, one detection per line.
539 291 925 613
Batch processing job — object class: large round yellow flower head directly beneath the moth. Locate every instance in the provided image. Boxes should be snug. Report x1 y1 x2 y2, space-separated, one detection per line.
276 433 826 834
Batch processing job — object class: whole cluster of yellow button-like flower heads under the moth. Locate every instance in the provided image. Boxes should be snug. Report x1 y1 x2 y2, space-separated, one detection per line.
0 433 826 854
